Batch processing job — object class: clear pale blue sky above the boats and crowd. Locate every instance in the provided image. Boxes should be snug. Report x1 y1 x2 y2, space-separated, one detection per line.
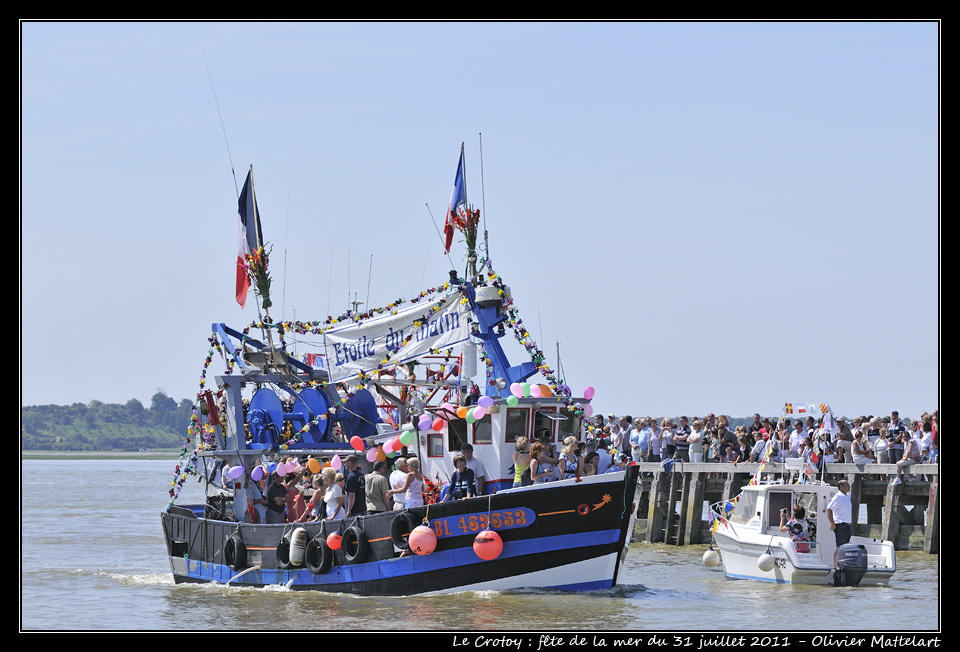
20 22 940 416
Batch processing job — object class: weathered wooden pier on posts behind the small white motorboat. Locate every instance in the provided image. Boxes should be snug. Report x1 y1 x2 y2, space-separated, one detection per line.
634 460 940 554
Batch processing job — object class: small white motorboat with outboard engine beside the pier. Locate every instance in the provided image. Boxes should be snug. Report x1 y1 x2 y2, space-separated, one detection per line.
704 403 897 586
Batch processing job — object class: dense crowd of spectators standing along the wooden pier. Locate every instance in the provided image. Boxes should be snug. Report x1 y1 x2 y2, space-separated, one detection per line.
587 410 940 482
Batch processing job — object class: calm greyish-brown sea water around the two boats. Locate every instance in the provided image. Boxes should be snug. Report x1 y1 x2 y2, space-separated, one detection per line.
20 460 940 632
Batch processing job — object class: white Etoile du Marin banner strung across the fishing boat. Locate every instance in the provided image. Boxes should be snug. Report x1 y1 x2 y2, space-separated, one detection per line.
323 294 470 382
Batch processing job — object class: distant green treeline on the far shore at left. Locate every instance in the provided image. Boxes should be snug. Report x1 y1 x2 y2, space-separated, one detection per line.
20 392 193 451
